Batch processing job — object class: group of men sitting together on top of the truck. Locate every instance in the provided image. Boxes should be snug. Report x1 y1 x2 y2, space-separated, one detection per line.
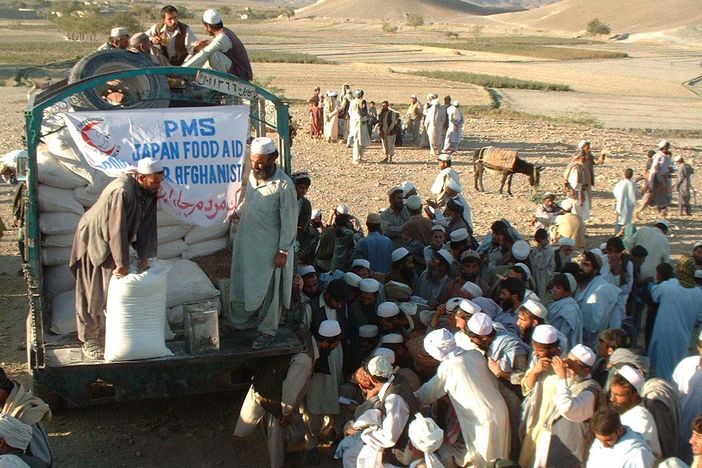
98 5 253 81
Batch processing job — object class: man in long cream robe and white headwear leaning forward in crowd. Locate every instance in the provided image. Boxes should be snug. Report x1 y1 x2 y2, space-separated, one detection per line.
417 328 510 466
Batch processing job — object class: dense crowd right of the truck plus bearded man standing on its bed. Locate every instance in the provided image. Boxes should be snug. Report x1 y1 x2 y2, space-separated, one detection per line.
221 132 702 468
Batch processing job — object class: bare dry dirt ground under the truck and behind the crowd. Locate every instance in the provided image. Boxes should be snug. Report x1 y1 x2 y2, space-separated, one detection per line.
0 21 702 467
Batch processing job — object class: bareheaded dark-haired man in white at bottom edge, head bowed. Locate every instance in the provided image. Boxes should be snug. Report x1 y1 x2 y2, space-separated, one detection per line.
587 408 655 468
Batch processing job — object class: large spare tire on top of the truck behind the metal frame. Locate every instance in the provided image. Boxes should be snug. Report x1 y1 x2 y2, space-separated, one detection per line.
68 49 170 110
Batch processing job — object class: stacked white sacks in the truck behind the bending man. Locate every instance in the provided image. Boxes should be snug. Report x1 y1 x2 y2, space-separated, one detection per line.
37 130 223 335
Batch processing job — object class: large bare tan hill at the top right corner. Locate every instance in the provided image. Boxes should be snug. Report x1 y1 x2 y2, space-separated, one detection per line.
494 0 702 33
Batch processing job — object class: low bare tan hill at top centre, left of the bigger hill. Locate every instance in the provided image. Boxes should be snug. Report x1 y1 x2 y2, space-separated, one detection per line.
295 0 505 23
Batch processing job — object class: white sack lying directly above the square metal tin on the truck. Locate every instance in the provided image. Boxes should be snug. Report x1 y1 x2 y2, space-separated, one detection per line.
166 259 219 307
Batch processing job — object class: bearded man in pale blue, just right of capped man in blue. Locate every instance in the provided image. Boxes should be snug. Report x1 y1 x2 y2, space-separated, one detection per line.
575 252 619 348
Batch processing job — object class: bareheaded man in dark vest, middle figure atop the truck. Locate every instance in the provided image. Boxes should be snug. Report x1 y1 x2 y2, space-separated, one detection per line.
146 5 197 67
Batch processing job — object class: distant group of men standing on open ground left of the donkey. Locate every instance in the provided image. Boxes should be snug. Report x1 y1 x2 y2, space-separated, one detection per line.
308 87 465 164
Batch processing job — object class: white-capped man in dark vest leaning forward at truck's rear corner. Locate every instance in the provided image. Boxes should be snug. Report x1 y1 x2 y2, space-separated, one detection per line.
234 320 328 468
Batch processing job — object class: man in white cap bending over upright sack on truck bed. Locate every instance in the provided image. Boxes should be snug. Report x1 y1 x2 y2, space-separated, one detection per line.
68 158 163 360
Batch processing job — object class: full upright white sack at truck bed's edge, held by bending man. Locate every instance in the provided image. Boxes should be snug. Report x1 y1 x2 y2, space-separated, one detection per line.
105 260 173 361
